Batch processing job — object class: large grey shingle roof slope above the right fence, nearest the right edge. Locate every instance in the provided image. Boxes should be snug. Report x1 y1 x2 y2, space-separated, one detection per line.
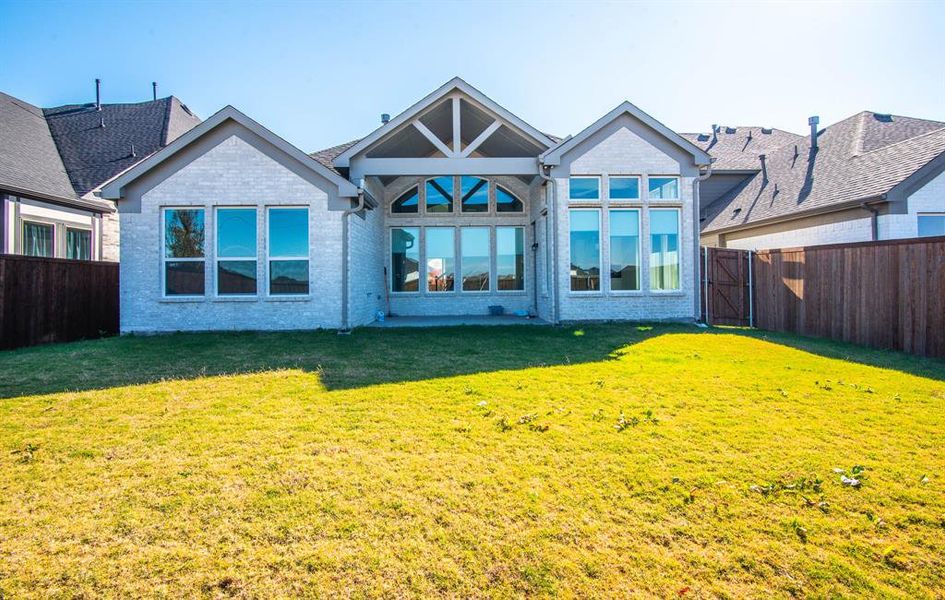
701 111 945 232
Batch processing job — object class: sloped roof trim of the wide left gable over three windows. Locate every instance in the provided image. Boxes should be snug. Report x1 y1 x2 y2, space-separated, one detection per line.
102 105 358 200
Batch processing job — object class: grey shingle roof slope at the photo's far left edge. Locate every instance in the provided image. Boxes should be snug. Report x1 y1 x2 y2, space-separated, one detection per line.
0 92 76 199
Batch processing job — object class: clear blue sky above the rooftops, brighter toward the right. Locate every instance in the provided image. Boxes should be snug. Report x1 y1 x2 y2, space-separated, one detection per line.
0 0 945 151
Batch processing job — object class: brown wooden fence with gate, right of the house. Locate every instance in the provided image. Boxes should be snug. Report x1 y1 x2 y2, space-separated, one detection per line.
703 237 945 356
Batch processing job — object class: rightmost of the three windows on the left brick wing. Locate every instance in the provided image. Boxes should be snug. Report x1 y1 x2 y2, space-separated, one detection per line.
268 207 309 296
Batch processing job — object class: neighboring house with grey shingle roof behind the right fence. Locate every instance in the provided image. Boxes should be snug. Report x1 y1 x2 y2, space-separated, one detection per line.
689 111 945 249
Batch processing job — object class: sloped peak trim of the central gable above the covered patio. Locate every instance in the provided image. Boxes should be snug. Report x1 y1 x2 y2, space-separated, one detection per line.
332 77 554 168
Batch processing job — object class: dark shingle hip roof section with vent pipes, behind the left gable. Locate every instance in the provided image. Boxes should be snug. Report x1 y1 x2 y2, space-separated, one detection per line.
43 96 200 196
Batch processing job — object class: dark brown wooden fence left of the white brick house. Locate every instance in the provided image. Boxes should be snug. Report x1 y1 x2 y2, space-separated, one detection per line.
0 254 118 350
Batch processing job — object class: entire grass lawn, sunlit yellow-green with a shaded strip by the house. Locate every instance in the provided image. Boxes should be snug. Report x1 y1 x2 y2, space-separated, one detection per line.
0 325 945 598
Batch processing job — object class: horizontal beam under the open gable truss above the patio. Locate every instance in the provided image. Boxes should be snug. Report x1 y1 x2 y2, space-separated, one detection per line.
351 157 538 179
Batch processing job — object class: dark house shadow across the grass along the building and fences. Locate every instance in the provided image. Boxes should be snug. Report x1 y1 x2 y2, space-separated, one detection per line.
0 324 945 398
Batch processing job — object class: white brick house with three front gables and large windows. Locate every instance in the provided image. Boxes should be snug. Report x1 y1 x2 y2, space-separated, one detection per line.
102 78 709 332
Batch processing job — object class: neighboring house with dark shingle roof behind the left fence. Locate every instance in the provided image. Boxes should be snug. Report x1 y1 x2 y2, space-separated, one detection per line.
0 87 200 260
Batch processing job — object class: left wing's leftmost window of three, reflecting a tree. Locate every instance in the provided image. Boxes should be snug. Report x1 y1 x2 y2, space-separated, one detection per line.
164 208 205 296
